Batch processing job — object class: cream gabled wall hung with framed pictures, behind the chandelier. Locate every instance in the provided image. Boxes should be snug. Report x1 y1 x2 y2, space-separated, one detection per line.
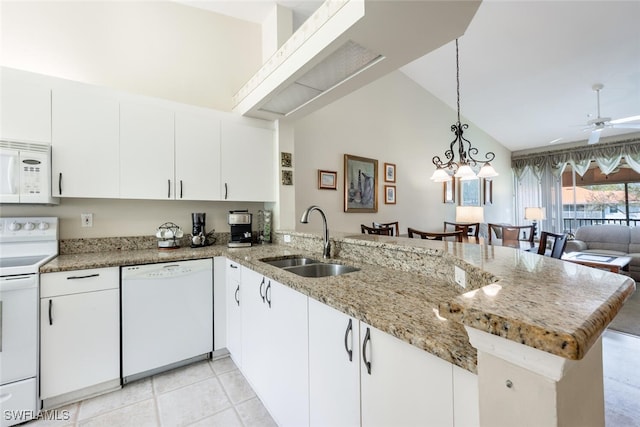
294 71 513 233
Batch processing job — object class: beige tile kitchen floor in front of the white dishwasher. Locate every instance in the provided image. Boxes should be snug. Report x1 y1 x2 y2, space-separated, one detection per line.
27 357 276 427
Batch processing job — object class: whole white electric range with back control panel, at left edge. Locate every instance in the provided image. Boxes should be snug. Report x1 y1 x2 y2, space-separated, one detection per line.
0 217 58 427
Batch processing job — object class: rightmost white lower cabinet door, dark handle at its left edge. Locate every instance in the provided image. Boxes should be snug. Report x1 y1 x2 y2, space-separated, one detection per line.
360 322 453 427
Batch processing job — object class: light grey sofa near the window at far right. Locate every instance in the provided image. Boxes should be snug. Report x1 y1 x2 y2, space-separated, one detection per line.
565 224 640 281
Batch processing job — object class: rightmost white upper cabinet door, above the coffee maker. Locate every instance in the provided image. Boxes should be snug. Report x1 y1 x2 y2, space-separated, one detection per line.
221 121 276 202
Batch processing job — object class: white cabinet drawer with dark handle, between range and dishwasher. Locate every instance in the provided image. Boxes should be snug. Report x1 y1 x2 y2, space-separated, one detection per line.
40 267 120 298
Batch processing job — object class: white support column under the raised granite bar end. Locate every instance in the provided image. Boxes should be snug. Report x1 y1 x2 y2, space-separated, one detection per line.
465 326 604 427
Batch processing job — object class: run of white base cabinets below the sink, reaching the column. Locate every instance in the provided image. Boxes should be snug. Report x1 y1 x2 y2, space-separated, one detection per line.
229 267 479 427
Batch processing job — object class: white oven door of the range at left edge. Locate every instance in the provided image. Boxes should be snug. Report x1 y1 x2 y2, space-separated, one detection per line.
0 274 38 384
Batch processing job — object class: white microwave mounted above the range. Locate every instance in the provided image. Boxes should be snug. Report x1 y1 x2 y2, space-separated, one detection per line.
0 141 58 204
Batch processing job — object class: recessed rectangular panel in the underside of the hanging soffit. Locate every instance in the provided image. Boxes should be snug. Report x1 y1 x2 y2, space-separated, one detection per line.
260 40 384 116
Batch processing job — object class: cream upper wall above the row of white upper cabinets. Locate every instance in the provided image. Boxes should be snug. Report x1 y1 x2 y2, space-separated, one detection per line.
0 1 262 111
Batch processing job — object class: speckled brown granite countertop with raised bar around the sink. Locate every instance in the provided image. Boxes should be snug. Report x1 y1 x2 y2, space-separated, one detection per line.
40 232 635 373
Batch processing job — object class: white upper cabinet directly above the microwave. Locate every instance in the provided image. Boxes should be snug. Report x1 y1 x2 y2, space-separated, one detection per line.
0 67 51 144
